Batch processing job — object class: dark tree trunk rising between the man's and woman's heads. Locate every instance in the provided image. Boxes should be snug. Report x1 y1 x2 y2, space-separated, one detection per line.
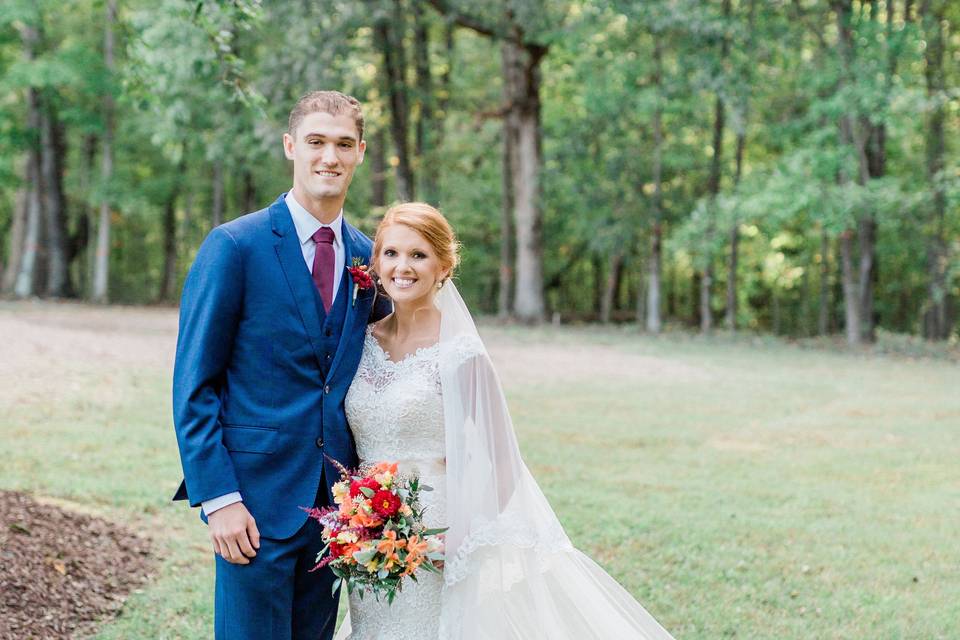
374 0 415 201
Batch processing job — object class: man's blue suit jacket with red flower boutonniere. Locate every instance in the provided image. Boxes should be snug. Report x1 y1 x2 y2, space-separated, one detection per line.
173 195 389 539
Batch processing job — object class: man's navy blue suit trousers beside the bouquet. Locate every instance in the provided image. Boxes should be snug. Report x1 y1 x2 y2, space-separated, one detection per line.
214 482 339 640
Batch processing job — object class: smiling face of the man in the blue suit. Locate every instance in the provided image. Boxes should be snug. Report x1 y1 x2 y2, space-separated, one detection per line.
283 111 366 204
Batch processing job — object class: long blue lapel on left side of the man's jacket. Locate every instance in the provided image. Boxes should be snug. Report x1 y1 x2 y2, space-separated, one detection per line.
270 194 323 370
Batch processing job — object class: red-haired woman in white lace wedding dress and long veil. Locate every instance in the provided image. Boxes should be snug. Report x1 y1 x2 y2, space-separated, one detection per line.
337 203 671 640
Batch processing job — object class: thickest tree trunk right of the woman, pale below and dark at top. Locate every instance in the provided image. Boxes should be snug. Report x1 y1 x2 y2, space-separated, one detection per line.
504 37 546 322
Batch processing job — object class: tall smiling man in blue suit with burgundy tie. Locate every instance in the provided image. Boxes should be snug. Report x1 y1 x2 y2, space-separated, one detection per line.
173 91 389 640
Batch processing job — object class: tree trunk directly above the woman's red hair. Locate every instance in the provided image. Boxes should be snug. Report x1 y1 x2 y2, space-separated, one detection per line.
413 2 440 204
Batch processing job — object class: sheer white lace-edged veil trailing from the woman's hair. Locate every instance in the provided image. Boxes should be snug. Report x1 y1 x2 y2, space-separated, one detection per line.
436 281 671 640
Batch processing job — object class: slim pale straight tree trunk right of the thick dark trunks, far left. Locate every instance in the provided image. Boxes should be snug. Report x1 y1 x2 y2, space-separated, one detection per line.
92 0 117 303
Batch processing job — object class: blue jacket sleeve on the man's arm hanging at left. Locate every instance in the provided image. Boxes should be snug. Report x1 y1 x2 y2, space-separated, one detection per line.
173 227 243 507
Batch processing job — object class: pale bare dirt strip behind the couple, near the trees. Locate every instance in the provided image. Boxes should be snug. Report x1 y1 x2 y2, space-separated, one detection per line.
0 302 711 405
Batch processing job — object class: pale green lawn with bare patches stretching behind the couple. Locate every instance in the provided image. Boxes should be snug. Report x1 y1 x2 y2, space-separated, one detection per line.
0 303 960 640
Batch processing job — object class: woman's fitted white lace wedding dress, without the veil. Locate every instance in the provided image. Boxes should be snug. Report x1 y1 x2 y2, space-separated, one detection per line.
345 328 446 640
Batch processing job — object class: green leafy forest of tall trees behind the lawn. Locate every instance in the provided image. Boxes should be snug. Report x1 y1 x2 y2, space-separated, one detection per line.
0 0 960 344
